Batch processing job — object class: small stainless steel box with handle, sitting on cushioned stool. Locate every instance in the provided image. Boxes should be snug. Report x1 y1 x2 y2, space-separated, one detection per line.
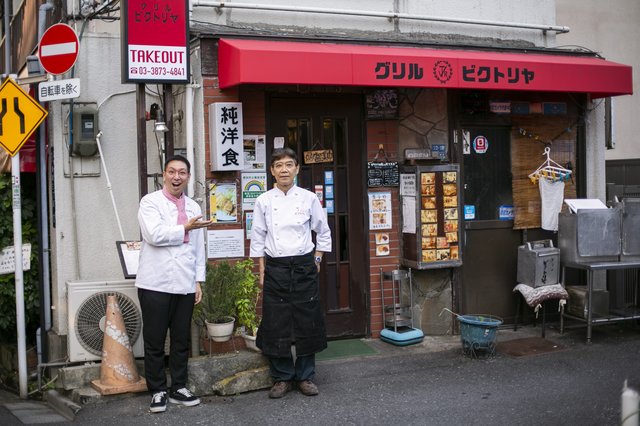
517 240 560 287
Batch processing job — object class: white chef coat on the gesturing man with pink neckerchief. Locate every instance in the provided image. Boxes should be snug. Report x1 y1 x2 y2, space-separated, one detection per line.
136 190 206 294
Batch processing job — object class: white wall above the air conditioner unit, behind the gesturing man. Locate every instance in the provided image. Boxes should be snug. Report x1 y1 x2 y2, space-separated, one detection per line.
48 33 168 334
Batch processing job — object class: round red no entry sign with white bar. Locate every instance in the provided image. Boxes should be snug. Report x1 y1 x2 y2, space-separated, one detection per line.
38 24 80 74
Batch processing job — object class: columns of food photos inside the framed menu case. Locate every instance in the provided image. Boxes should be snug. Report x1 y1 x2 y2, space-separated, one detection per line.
419 171 460 263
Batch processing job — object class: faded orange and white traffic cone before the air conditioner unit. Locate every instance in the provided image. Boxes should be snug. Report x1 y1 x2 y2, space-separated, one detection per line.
91 295 147 395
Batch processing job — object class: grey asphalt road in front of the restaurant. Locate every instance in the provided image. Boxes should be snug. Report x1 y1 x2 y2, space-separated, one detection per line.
6 325 640 426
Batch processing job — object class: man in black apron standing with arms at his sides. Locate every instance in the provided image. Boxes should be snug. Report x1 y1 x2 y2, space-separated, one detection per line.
250 148 331 398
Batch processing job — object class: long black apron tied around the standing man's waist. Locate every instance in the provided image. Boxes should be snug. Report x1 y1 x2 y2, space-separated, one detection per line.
256 253 327 358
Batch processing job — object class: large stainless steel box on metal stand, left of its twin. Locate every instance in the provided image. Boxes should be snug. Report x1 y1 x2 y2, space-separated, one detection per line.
558 207 622 263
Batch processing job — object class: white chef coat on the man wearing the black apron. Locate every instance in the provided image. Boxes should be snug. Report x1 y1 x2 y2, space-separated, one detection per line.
249 185 331 257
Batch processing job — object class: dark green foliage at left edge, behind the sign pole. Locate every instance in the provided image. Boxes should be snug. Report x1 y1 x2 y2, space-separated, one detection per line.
0 173 40 343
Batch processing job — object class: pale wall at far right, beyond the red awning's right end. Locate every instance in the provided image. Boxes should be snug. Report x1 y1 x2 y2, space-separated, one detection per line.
556 0 640 161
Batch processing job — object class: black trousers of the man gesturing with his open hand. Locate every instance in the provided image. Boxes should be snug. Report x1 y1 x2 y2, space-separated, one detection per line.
138 288 195 392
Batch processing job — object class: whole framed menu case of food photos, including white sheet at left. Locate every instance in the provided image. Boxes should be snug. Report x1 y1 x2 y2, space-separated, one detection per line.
402 164 462 269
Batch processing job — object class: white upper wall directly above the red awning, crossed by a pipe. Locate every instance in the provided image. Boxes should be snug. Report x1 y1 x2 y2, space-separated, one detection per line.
191 0 555 47
